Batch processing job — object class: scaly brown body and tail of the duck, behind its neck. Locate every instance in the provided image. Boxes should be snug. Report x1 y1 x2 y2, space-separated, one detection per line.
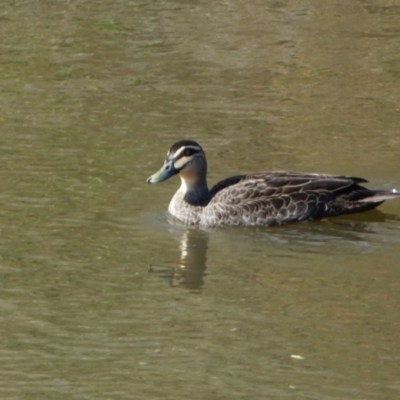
204 171 393 225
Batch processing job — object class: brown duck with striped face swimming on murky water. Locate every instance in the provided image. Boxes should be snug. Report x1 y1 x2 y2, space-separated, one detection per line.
147 140 400 227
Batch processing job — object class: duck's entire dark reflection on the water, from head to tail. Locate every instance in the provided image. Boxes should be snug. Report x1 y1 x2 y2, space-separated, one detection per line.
149 210 400 293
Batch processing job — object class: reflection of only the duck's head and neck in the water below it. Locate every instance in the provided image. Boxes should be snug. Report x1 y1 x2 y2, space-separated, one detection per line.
149 228 208 291
